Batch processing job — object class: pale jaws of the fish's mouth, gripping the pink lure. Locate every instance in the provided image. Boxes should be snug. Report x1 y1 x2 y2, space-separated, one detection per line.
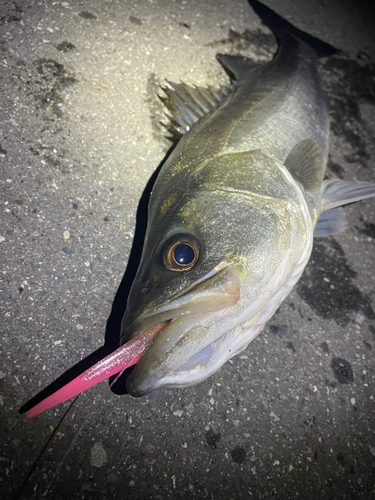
126 263 240 397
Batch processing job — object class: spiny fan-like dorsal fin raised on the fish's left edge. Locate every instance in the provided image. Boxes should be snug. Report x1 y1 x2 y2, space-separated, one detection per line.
159 82 232 135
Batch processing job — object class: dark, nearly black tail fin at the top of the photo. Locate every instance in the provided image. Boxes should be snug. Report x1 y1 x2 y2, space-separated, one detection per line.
248 0 339 57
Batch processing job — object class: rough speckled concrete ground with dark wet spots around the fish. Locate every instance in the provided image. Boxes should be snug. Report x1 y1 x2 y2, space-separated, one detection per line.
0 0 375 500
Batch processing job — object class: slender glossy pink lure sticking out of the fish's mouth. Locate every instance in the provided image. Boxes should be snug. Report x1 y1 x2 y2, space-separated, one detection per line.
27 321 169 418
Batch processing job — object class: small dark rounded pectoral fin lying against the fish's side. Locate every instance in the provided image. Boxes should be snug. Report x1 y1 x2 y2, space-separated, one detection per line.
284 139 323 191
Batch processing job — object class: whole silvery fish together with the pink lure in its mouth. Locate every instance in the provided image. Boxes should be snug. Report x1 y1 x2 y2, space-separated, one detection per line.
22 0 375 417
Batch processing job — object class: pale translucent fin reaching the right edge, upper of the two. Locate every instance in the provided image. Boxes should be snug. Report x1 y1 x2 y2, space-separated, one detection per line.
322 179 375 211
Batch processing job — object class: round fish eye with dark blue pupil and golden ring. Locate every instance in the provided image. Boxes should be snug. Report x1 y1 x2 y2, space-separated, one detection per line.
163 235 199 271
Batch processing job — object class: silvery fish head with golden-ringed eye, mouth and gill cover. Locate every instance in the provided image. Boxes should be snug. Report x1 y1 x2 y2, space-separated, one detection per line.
121 148 308 396
